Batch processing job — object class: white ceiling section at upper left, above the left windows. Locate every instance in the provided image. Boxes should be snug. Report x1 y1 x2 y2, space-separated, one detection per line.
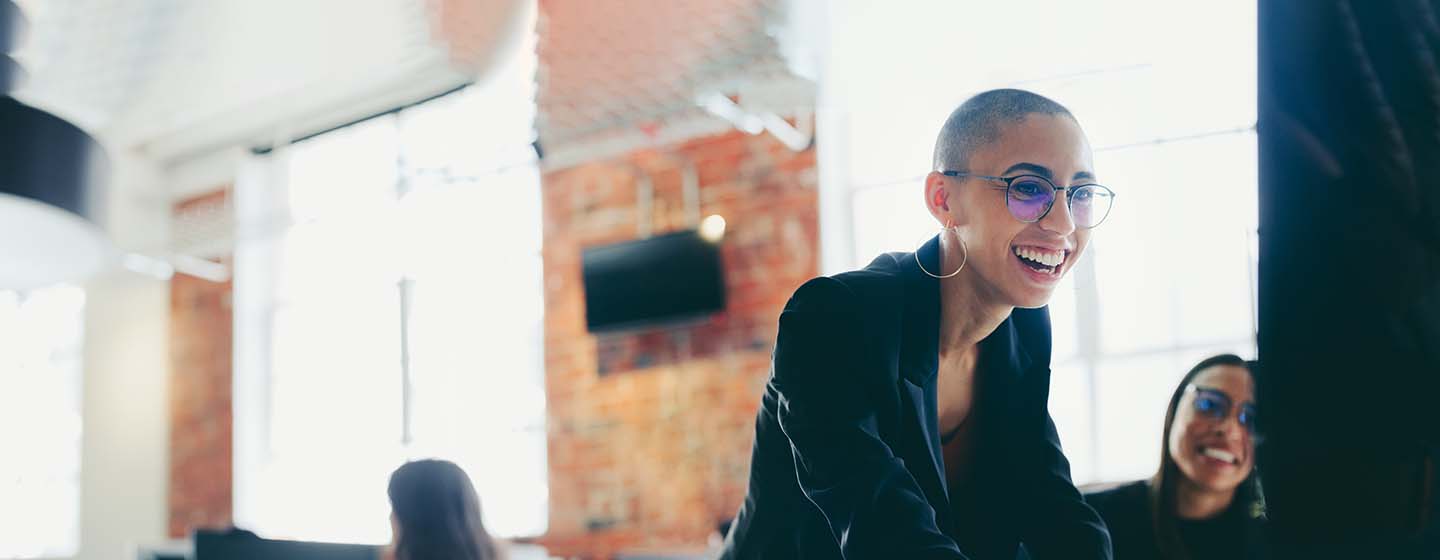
9 0 533 161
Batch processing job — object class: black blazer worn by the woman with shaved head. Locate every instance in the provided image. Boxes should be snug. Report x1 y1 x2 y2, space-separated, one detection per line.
721 238 1110 560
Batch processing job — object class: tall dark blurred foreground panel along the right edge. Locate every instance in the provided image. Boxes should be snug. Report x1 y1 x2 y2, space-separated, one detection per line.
1259 0 1440 559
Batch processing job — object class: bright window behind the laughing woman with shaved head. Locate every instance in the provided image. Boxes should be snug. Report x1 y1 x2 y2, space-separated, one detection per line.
835 0 1259 484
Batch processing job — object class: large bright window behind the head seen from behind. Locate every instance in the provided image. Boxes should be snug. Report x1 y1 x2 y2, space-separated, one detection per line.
235 32 549 543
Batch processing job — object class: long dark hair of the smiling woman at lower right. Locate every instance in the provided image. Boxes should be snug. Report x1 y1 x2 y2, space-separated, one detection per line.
1151 354 1264 559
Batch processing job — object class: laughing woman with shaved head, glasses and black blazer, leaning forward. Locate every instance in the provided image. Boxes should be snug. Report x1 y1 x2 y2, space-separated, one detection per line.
721 89 1113 560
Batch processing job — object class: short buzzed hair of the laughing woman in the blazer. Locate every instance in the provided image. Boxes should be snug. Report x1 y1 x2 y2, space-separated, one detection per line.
933 89 1074 171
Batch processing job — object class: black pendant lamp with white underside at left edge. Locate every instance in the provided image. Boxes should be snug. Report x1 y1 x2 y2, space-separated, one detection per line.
0 0 109 289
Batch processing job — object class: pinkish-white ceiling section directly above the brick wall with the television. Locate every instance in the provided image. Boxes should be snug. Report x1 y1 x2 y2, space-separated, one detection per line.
537 0 824 167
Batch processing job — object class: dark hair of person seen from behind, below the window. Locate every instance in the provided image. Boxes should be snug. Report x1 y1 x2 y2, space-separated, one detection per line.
389 459 500 560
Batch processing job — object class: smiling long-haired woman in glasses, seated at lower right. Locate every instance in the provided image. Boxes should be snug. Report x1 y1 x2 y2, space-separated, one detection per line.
1086 354 1264 560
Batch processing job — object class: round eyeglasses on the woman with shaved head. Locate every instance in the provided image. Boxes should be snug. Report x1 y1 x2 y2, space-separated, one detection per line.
940 171 1115 229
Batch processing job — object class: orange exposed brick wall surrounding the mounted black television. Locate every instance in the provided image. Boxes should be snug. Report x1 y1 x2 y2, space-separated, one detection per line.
543 132 818 557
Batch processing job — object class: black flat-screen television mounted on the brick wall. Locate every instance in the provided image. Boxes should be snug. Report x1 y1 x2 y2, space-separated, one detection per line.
580 230 726 333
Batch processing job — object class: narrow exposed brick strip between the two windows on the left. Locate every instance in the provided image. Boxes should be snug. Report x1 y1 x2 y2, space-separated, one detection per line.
170 191 232 537
